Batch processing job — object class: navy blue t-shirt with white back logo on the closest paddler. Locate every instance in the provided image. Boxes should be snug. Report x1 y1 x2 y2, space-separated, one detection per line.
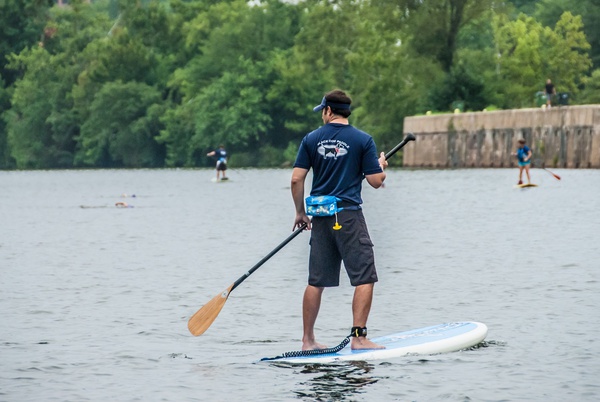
294 123 382 205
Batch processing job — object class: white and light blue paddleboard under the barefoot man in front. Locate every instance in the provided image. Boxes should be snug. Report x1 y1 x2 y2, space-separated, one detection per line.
263 322 487 364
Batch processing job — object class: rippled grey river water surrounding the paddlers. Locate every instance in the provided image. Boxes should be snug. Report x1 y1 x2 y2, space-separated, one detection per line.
0 169 600 402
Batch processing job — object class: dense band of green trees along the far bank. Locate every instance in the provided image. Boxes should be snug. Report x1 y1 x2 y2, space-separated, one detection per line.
0 0 600 169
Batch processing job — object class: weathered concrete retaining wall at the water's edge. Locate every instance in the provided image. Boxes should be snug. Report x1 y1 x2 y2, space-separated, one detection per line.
404 105 600 168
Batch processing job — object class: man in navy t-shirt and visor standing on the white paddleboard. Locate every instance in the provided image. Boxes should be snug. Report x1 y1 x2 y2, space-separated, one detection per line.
291 90 387 350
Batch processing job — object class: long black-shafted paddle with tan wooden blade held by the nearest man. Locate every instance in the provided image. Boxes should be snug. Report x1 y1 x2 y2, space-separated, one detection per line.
188 133 415 336
